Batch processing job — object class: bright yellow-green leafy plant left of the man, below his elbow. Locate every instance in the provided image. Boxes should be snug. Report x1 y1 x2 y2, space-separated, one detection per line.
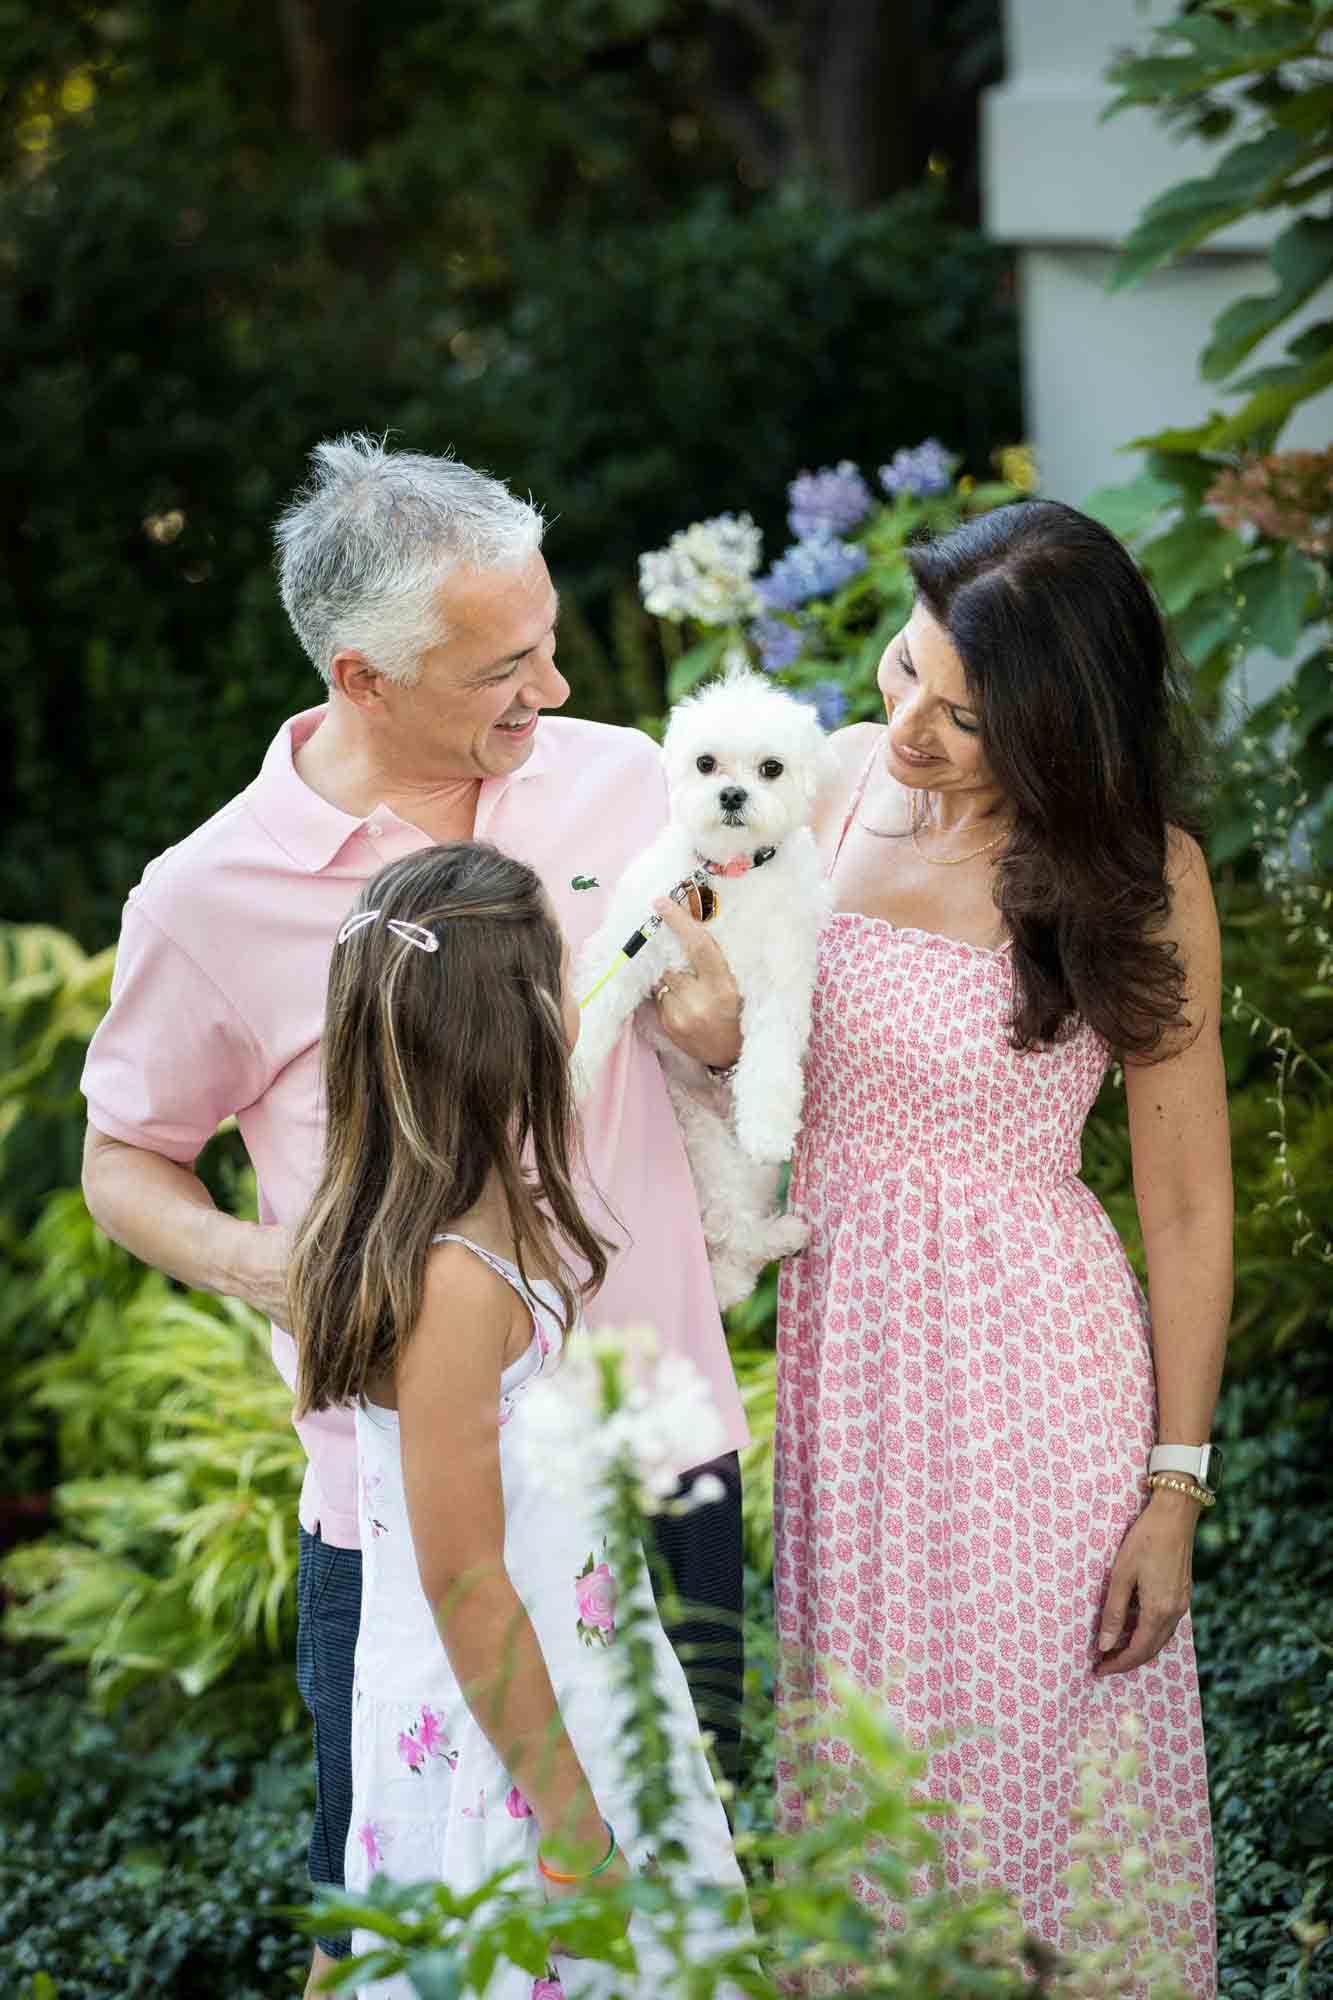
4 1194 304 1714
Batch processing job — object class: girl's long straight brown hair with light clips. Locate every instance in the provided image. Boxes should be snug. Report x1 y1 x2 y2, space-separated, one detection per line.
290 840 608 1416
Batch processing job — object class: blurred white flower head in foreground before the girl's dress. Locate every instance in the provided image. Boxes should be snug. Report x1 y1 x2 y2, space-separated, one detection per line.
508 1326 727 1508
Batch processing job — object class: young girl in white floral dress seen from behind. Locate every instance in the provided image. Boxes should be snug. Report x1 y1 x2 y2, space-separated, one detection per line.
290 840 741 2000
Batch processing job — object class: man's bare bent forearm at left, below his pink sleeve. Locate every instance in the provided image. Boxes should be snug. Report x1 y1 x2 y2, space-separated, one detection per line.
84 1126 286 1322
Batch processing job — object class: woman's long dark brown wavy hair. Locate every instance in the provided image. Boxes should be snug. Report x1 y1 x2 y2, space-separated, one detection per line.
907 500 1197 1060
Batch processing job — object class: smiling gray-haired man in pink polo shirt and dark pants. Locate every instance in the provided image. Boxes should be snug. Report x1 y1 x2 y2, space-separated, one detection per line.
84 436 747 1978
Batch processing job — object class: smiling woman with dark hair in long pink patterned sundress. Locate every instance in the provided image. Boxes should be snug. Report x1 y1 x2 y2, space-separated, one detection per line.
777 500 1231 1996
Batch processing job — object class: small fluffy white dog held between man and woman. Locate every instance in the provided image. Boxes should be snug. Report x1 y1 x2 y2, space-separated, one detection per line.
576 670 833 1306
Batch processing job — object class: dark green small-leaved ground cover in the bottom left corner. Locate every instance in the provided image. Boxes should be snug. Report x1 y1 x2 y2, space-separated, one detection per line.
0 1648 314 2000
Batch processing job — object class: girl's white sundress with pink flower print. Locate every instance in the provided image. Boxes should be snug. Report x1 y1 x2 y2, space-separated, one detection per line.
346 1236 741 2000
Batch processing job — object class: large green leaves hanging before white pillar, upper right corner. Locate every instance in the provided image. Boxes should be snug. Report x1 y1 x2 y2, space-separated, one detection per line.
1107 0 1333 452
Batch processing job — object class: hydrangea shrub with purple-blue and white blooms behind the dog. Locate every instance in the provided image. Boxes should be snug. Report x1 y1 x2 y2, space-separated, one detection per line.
638 438 1037 730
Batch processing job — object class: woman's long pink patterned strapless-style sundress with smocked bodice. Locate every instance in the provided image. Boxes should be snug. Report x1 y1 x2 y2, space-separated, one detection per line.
775 756 1217 2000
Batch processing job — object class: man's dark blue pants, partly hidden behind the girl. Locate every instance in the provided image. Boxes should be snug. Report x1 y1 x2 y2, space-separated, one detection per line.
296 1452 745 1958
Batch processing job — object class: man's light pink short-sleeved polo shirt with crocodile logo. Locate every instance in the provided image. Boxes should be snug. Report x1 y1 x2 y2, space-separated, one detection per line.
82 708 749 1548
